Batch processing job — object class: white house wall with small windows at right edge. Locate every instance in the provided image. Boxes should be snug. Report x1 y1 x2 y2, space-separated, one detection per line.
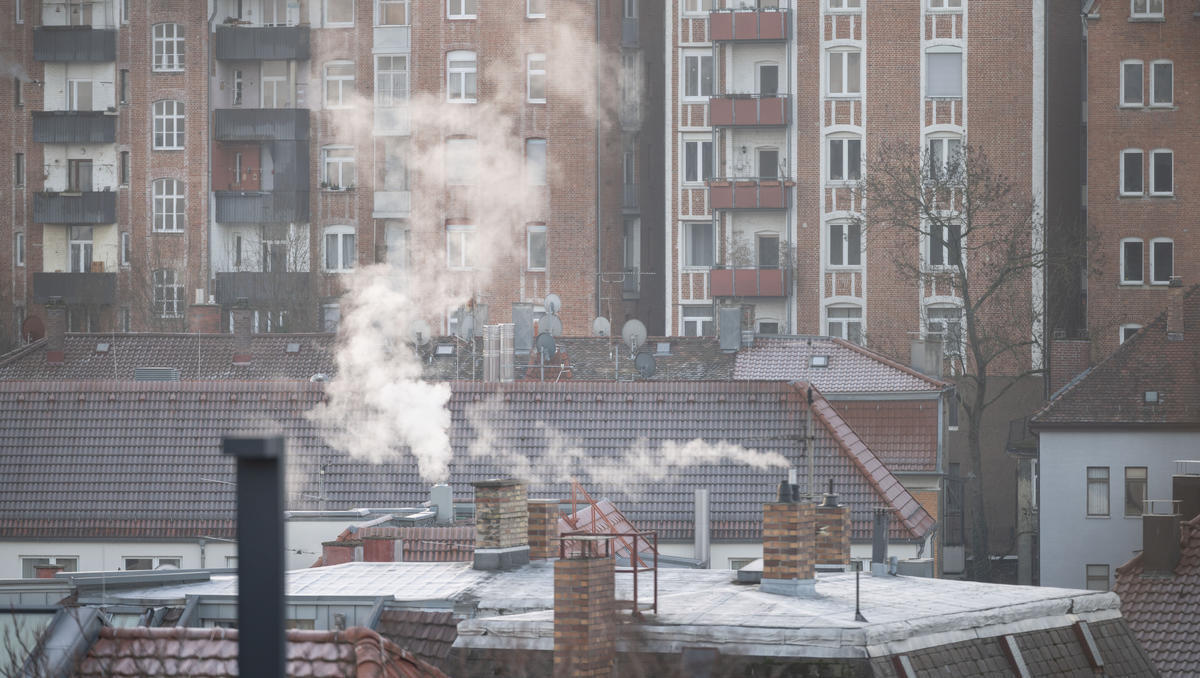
1038 431 1200 588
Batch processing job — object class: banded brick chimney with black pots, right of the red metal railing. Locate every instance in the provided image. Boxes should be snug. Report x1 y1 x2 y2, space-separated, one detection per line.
758 481 816 595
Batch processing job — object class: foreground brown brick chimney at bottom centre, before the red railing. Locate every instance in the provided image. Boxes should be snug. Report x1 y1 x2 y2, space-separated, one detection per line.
554 548 617 678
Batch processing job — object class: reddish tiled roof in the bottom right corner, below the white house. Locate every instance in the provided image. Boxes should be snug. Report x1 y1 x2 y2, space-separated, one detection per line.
1114 517 1200 678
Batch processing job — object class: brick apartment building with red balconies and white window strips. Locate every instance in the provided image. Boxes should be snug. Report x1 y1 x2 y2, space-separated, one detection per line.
665 0 1045 368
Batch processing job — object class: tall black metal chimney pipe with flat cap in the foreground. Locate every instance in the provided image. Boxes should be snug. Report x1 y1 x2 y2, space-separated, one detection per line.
221 436 287 678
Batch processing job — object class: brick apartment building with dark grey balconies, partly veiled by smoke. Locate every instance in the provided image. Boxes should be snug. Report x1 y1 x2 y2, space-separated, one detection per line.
0 0 662 348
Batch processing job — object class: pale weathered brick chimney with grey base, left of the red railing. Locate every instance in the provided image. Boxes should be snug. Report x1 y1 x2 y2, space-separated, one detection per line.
472 478 529 570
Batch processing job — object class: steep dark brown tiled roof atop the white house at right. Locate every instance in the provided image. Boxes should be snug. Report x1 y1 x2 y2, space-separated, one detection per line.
1032 286 1200 428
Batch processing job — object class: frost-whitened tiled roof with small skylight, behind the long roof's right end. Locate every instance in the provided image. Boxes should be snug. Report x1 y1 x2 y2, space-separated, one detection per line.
733 336 949 394
